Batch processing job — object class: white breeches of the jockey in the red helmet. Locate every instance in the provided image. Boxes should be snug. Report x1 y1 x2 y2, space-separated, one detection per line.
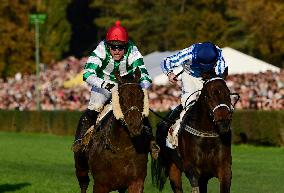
88 86 111 112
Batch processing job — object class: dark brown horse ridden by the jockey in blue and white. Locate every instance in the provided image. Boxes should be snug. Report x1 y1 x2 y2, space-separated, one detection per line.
152 78 238 193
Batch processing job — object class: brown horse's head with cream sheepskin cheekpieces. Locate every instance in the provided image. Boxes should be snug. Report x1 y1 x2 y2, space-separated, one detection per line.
112 68 149 137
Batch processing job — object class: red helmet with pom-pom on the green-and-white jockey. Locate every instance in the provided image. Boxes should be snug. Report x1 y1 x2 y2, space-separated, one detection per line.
106 21 128 43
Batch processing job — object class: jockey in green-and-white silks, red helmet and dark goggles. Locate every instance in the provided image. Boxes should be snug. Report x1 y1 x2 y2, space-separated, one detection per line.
72 21 159 159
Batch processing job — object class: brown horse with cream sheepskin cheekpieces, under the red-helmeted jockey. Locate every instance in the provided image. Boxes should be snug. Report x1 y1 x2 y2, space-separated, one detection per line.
74 68 150 193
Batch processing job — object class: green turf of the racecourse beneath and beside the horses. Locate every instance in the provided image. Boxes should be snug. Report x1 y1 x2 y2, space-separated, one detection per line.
0 132 284 193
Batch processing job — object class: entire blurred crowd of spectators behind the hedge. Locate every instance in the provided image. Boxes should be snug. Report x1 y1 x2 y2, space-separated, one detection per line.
0 57 284 111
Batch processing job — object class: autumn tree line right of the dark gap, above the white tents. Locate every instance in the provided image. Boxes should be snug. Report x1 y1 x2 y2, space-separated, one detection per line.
91 0 284 67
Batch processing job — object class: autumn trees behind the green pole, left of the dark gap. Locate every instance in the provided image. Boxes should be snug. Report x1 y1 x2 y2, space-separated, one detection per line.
0 0 71 78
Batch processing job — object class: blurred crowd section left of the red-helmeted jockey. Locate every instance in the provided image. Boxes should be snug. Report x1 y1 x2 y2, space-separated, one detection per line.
0 57 89 111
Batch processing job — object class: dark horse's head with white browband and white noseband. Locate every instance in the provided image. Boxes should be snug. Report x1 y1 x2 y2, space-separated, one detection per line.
200 77 234 134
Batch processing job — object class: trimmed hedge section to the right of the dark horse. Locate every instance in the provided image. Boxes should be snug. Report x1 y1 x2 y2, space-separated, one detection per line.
232 111 284 146
